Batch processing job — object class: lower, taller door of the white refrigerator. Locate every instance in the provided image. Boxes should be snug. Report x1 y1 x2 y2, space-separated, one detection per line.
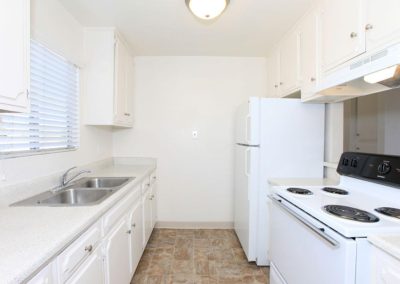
234 145 259 261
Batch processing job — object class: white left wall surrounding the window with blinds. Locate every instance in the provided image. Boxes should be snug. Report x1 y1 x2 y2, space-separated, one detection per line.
0 0 112 186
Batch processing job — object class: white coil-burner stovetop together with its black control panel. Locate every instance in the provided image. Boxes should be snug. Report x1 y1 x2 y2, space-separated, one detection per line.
272 152 400 238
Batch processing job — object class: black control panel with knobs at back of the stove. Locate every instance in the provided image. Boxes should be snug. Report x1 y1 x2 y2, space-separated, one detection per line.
337 152 400 186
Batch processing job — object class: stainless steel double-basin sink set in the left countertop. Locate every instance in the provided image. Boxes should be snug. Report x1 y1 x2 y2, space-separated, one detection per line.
11 177 134 206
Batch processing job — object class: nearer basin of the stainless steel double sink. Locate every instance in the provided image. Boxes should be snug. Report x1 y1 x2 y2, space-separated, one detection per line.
39 188 114 206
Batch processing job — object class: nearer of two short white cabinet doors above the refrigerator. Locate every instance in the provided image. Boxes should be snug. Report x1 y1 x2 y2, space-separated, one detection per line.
279 32 299 96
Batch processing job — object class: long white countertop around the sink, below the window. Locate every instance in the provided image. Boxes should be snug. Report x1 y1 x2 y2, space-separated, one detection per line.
0 163 156 283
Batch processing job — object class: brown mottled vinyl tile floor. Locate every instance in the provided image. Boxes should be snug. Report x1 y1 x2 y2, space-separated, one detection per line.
131 229 269 284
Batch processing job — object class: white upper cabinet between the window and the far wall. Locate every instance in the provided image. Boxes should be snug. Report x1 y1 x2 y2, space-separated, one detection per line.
84 28 134 127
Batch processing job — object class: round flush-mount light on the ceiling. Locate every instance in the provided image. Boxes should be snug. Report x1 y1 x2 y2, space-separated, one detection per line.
185 0 229 20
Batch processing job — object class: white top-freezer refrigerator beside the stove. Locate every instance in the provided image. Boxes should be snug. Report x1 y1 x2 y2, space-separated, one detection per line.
234 97 325 266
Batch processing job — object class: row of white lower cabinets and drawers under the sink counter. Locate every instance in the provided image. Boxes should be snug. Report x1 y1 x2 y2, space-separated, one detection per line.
28 173 156 284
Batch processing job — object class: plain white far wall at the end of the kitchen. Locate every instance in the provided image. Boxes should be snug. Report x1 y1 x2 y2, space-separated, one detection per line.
113 57 266 225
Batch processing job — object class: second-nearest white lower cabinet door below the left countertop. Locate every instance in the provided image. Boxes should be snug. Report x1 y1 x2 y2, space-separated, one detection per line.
105 218 130 284
